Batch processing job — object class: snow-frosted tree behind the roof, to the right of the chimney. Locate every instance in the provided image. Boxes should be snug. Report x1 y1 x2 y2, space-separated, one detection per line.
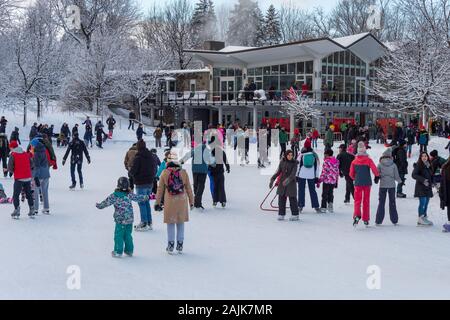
227 0 262 47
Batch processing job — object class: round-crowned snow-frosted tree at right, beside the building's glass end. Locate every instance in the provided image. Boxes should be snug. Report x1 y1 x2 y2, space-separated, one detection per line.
373 38 450 126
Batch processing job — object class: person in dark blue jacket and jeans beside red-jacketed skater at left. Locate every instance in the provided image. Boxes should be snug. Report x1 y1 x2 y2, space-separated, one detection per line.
31 139 51 215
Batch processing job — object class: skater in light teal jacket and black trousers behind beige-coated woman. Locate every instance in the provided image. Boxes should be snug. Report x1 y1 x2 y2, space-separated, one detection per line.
180 142 211 210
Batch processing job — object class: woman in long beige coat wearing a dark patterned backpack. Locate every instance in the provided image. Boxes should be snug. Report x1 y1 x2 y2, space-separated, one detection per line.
155 152 194 254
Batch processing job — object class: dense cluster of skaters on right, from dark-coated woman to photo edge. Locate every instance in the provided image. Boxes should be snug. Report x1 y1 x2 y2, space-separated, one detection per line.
269 122 450 231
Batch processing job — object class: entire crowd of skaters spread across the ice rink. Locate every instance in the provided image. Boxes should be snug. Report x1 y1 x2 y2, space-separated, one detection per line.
0 111 450 257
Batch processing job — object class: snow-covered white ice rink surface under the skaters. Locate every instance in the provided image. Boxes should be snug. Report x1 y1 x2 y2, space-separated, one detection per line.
0 106 450 299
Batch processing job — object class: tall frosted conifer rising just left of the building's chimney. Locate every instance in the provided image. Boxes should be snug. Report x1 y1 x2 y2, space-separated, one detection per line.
191 0 217 48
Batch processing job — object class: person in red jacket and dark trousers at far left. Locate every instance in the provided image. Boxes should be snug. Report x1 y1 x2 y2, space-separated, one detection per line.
8 140 34 219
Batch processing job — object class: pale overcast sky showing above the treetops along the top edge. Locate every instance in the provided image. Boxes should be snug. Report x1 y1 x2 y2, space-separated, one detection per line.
137 0 337 12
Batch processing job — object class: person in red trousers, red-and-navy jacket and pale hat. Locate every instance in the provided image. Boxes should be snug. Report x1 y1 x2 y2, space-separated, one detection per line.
350 141 380 226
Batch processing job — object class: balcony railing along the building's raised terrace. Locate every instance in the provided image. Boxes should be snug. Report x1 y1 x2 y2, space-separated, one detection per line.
150 89 383 107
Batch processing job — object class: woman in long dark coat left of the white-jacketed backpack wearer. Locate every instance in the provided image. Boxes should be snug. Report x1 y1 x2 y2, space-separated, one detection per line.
269 150 299 221
